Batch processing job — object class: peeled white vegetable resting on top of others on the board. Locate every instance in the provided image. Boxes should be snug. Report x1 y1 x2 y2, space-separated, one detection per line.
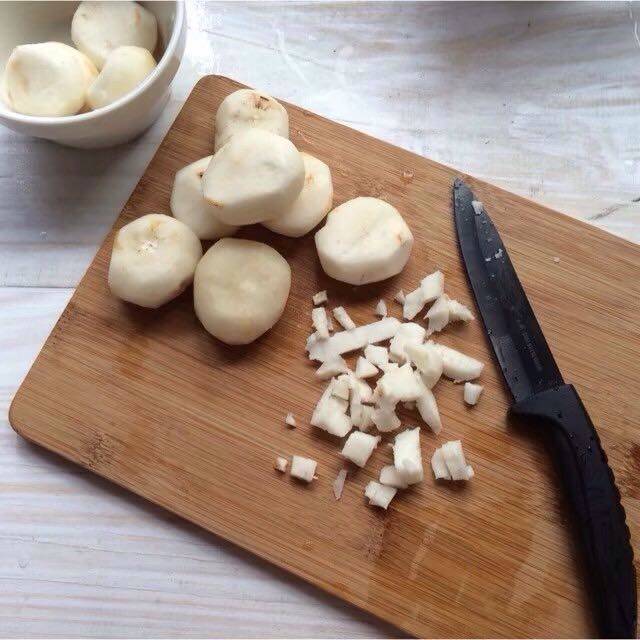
202 129 304 225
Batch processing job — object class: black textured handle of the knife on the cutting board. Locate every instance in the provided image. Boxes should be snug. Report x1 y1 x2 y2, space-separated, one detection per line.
511 385 637 638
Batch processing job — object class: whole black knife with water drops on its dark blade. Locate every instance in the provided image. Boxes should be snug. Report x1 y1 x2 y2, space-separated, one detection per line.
453 179 637 638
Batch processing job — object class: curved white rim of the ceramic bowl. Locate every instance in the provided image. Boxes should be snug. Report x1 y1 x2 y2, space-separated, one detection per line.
0 0 186 126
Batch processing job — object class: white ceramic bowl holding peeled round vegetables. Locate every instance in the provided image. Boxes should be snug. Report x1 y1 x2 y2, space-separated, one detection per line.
0 1 187 149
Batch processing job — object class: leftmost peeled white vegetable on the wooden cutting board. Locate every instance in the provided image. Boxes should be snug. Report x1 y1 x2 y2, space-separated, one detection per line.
109 213 202 309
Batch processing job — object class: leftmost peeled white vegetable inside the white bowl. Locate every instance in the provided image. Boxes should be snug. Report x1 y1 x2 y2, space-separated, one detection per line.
3 42 98 117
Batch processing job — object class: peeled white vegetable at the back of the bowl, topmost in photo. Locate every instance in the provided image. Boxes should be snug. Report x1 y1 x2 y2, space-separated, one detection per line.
71 2 158 69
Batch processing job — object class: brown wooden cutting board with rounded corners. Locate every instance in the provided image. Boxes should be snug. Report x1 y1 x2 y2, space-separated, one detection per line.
10 76 640 637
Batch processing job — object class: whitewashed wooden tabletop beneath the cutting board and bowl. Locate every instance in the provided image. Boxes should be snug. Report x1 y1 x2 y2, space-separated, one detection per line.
0 0 640 637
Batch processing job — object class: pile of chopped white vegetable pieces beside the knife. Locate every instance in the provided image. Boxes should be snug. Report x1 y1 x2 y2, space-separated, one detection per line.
275 271 484 509
